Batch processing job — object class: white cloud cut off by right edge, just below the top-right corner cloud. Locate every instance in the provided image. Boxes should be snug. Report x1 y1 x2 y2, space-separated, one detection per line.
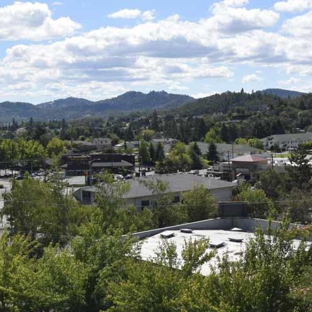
282 11 312 37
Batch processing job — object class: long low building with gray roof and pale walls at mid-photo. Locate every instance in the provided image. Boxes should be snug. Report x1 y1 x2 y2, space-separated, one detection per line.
74 173 235 209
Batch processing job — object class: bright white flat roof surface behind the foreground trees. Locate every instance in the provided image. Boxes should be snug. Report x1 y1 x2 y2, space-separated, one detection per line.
141 229 300 275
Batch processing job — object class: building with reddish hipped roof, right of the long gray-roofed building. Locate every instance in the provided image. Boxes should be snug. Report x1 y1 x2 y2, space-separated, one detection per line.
232 155 269 180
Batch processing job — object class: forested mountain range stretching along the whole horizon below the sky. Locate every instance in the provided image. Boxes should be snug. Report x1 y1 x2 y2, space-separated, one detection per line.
0 89 303 123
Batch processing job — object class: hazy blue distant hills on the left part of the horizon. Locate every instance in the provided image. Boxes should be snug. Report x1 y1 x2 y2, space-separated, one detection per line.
0 91 194 122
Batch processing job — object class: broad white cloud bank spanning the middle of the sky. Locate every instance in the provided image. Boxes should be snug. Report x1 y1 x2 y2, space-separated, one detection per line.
0 0 312 99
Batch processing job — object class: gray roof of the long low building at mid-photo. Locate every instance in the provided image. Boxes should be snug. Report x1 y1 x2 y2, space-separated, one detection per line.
83 173 235 198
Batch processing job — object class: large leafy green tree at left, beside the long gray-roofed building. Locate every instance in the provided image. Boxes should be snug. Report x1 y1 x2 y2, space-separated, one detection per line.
1 175 89 244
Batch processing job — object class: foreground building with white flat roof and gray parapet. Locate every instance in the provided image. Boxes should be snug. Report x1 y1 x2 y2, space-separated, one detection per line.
133 217 304 275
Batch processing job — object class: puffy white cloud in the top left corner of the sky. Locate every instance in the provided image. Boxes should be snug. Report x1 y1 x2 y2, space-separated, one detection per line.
0 1 81 41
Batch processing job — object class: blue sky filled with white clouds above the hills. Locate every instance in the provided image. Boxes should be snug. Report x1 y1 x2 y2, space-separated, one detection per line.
0 0 312 104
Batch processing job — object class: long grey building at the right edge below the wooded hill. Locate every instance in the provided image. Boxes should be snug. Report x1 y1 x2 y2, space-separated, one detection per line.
261 132 312 151
